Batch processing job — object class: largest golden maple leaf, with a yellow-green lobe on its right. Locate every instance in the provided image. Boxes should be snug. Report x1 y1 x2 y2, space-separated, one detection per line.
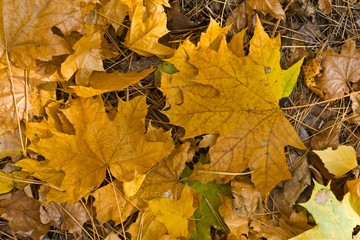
161 17 305 195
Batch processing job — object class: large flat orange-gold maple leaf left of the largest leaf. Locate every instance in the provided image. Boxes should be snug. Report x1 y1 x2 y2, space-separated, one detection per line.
17 97 173 202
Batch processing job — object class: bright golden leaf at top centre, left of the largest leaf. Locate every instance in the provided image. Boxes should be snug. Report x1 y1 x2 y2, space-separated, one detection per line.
124 3 174 57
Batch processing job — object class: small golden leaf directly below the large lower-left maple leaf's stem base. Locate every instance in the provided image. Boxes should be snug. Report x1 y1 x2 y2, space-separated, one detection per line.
91 181 138 224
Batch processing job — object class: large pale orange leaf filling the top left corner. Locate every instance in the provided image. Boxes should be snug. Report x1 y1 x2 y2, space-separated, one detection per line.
0 0 83 69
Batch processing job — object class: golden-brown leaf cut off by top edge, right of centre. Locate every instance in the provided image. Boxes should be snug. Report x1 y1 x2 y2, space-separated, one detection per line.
246 0 285 21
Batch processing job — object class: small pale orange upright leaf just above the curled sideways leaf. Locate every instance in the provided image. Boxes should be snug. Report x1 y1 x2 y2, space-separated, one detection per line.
61 31 104 86
